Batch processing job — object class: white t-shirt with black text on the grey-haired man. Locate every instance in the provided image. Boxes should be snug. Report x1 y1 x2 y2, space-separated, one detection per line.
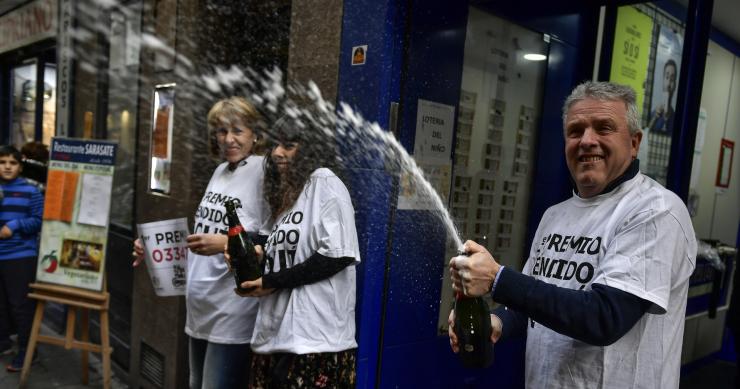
523 173 697 389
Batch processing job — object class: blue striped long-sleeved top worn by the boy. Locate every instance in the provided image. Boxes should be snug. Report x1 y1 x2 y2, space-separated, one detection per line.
0 177 44 260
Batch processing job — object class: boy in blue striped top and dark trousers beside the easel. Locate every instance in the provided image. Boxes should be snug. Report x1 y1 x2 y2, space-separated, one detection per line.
0 146 44 372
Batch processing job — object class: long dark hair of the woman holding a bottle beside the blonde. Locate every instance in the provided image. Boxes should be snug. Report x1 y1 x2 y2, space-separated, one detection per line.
264 115 338 221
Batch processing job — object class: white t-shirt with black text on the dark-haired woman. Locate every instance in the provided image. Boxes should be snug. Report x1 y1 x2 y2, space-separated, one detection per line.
252 168 360 354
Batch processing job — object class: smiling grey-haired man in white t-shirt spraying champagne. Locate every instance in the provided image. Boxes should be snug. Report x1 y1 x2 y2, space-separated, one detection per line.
450 82 696 389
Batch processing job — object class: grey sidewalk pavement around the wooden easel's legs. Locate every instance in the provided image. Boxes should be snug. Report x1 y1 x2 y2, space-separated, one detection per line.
0 324 128 389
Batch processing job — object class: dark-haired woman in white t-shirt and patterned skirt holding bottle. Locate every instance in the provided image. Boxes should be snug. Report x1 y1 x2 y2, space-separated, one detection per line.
242 118 360 388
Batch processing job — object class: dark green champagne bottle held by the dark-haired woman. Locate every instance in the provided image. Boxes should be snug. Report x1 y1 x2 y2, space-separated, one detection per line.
224 200 262 292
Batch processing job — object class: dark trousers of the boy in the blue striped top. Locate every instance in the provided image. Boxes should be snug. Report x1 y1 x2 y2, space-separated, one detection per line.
0 258 36 348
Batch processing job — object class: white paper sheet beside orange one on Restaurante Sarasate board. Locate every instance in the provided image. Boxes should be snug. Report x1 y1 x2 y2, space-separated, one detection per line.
77 174 113 227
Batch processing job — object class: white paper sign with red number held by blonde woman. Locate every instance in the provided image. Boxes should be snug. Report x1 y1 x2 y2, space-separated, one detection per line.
138 218 189 296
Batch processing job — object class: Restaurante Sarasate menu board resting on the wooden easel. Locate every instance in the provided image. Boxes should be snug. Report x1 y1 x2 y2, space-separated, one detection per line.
36 138 117 291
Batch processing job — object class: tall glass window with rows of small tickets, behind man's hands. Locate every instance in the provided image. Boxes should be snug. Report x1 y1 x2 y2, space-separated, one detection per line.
439 7 548 332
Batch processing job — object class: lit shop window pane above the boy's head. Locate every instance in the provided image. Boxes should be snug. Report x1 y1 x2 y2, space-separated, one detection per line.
10 62 36 149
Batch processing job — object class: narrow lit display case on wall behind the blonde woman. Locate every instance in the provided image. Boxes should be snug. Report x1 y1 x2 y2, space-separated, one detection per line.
149 84 175 195
